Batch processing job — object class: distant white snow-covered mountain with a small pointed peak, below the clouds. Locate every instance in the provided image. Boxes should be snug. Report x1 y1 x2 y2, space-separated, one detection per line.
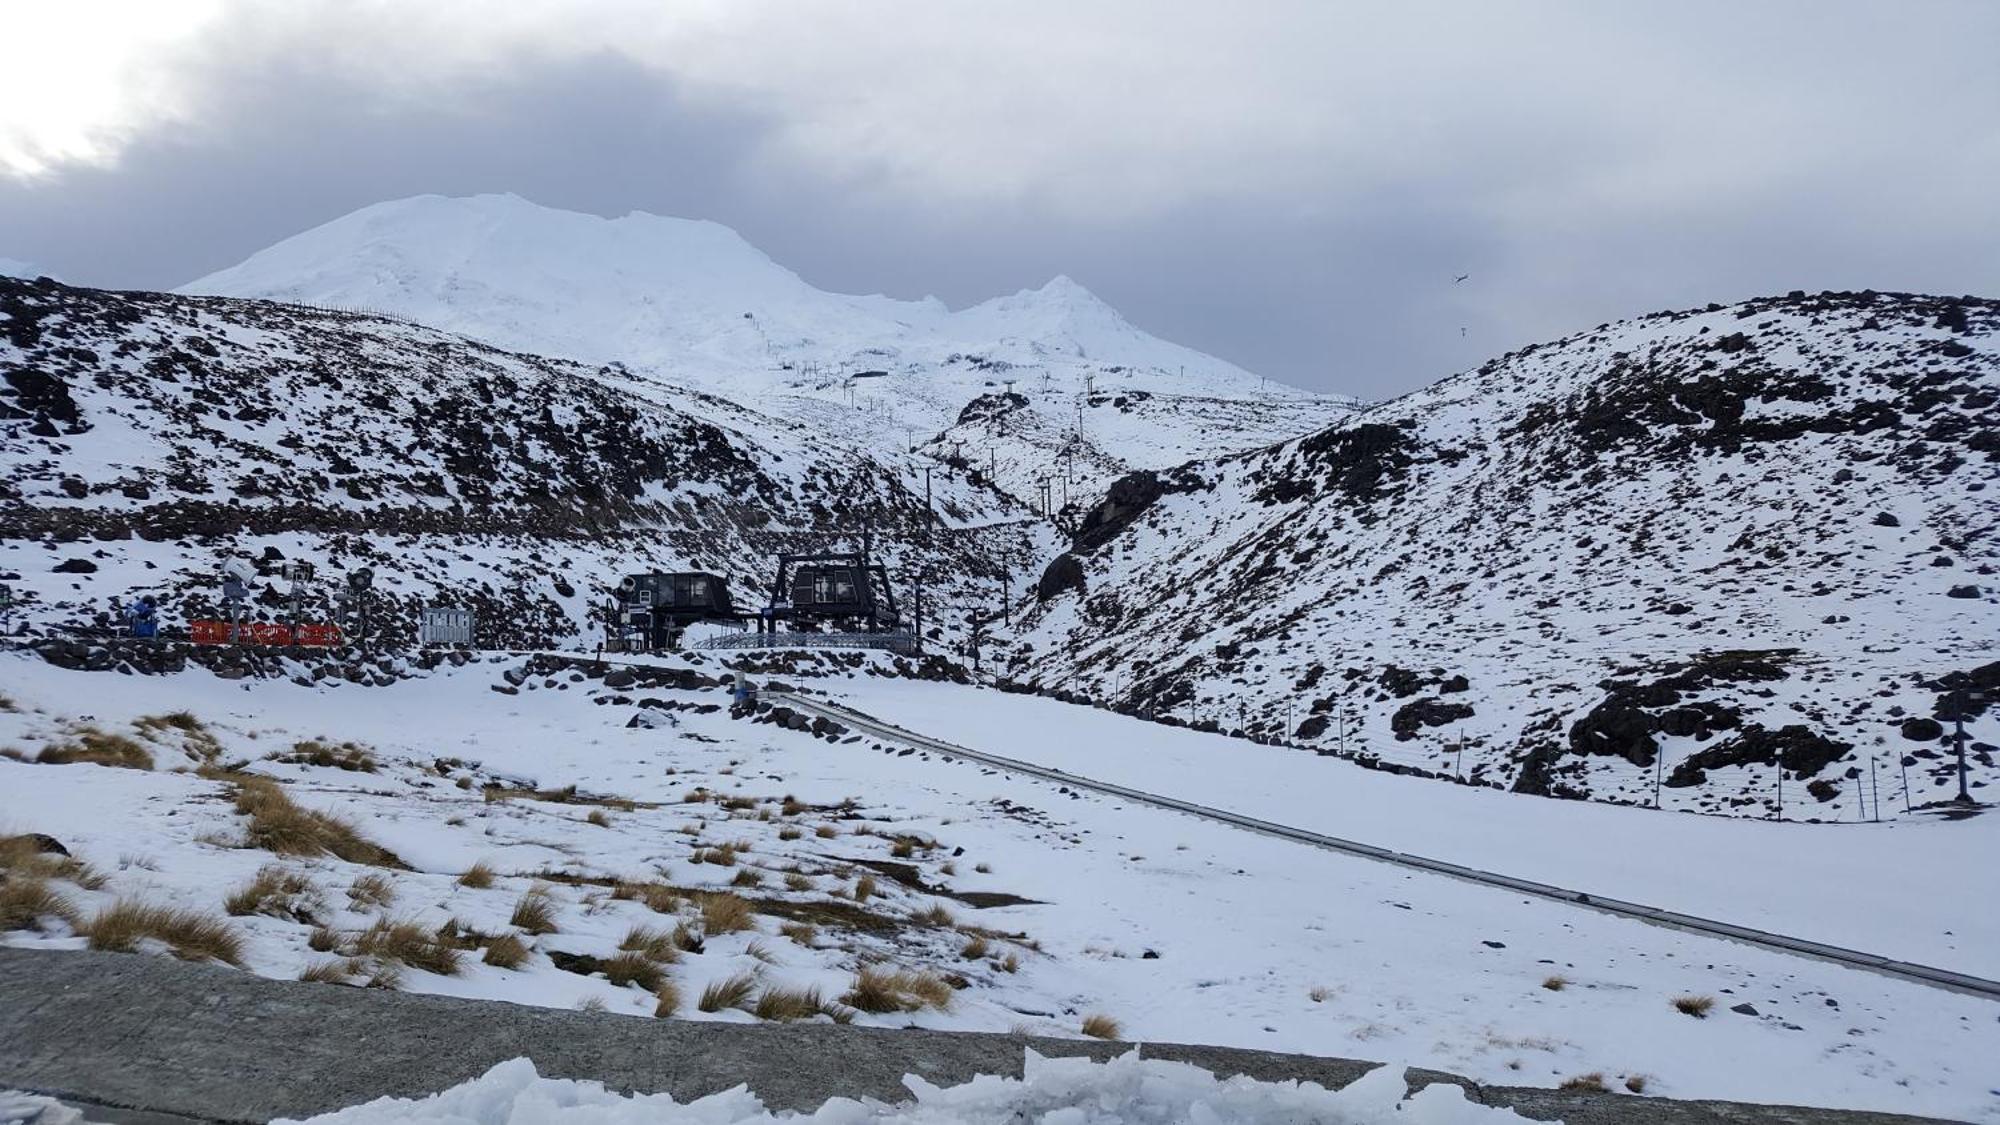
184 194 1354 506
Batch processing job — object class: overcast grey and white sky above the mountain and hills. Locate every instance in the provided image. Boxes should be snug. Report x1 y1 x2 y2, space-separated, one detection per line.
0 0 2000 398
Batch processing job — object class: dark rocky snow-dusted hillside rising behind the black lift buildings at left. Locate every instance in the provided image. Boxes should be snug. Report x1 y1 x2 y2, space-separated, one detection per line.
0 278 1054 647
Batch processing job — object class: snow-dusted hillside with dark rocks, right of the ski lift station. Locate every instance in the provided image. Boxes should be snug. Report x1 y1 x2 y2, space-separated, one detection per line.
1016 292 2000 819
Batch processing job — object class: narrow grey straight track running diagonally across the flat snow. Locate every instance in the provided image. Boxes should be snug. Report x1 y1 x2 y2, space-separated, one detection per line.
764 689 2000 1001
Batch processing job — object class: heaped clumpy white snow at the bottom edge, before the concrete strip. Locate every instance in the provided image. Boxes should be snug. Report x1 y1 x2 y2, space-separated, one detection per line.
278 1051 1524 1125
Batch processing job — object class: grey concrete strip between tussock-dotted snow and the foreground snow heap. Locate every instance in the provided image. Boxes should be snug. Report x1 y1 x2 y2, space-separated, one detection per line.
0 949 1922 1125
